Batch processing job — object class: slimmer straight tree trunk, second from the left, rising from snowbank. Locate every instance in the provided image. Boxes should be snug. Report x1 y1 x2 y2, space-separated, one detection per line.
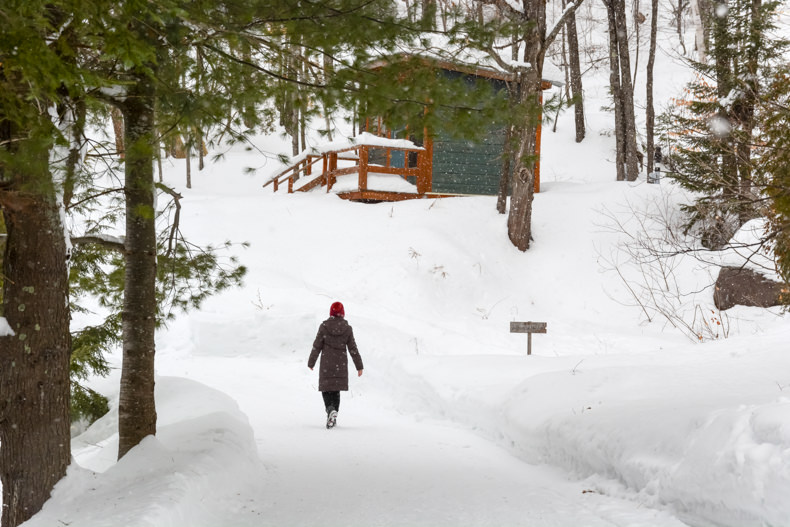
118 66 156 458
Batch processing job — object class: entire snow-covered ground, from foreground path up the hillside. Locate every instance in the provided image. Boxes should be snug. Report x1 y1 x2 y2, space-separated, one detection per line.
17 8 790 527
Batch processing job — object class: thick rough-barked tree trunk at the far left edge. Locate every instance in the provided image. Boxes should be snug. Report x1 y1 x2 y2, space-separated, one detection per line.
0 54 71 527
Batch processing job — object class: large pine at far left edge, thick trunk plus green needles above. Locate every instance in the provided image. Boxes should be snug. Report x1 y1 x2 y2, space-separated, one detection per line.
0 0 92 527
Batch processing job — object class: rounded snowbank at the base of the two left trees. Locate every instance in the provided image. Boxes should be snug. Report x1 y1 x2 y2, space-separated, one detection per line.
24 377 264 527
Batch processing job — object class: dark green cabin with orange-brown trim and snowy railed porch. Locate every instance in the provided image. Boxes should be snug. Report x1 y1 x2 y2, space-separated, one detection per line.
264 61 555 201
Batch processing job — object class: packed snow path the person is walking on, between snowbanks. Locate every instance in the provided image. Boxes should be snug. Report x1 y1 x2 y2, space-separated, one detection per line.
159 350 682 526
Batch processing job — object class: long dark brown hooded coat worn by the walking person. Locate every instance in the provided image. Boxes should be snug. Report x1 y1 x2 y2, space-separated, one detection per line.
307 317 362 392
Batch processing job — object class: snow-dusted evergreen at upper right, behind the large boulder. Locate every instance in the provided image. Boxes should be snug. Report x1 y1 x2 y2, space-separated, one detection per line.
662 0 787 248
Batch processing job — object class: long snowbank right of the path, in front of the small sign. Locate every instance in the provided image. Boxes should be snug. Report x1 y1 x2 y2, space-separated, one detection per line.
388 330 790 527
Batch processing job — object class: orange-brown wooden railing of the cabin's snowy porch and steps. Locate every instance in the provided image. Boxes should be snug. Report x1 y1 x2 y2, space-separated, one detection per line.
263 139 431 194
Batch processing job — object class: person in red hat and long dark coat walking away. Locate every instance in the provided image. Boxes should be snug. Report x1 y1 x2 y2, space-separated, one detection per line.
307 302 363 428
